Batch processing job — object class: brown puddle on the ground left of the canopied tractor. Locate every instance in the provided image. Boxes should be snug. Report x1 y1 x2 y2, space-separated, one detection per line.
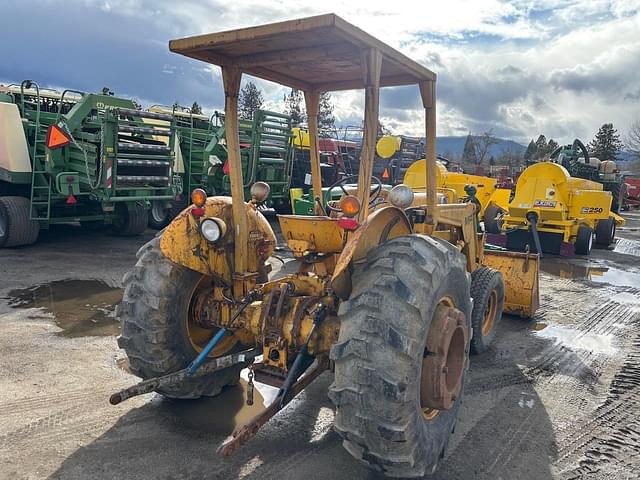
8 280 122 337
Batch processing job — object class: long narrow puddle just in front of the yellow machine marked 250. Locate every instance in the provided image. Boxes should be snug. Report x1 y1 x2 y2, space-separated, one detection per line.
540 258 640 287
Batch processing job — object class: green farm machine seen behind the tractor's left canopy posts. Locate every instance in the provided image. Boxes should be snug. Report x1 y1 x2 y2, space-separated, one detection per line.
149 105 293 229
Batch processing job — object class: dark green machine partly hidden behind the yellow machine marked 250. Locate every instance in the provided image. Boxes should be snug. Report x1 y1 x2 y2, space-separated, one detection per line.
550 138 627 214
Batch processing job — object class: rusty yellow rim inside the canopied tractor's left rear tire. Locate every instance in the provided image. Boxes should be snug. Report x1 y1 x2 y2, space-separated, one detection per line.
185 276 238 357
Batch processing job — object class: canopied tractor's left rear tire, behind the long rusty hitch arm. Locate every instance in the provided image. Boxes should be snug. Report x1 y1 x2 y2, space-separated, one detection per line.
117 237 245 398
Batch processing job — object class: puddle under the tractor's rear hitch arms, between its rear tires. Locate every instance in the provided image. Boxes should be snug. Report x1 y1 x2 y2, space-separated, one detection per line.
163 369 278 435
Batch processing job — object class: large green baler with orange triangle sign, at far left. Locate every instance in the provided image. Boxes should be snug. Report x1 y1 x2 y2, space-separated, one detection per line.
0 80 180 247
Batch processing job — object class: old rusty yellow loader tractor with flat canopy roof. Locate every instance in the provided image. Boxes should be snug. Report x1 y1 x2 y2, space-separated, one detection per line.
110 14 538 477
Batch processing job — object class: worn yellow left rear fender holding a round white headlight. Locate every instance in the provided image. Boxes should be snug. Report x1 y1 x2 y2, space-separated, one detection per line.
160 197 276 283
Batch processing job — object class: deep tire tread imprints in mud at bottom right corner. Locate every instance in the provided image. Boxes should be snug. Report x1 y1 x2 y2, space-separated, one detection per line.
559 335 640 480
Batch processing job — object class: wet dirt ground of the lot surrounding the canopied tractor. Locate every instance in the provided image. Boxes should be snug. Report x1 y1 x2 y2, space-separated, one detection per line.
0 212 640 480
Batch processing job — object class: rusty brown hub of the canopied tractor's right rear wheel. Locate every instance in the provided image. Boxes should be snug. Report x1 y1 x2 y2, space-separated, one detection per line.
420 304 469 412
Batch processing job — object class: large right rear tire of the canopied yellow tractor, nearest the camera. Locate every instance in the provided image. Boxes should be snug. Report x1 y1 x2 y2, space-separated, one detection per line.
329 235 471 477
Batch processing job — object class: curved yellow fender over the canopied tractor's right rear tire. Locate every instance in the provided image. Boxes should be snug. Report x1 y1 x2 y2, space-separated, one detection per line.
331 206 412 300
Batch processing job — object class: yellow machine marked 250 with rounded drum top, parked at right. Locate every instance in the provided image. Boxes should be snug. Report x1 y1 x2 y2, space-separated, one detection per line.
485 162 624 256
